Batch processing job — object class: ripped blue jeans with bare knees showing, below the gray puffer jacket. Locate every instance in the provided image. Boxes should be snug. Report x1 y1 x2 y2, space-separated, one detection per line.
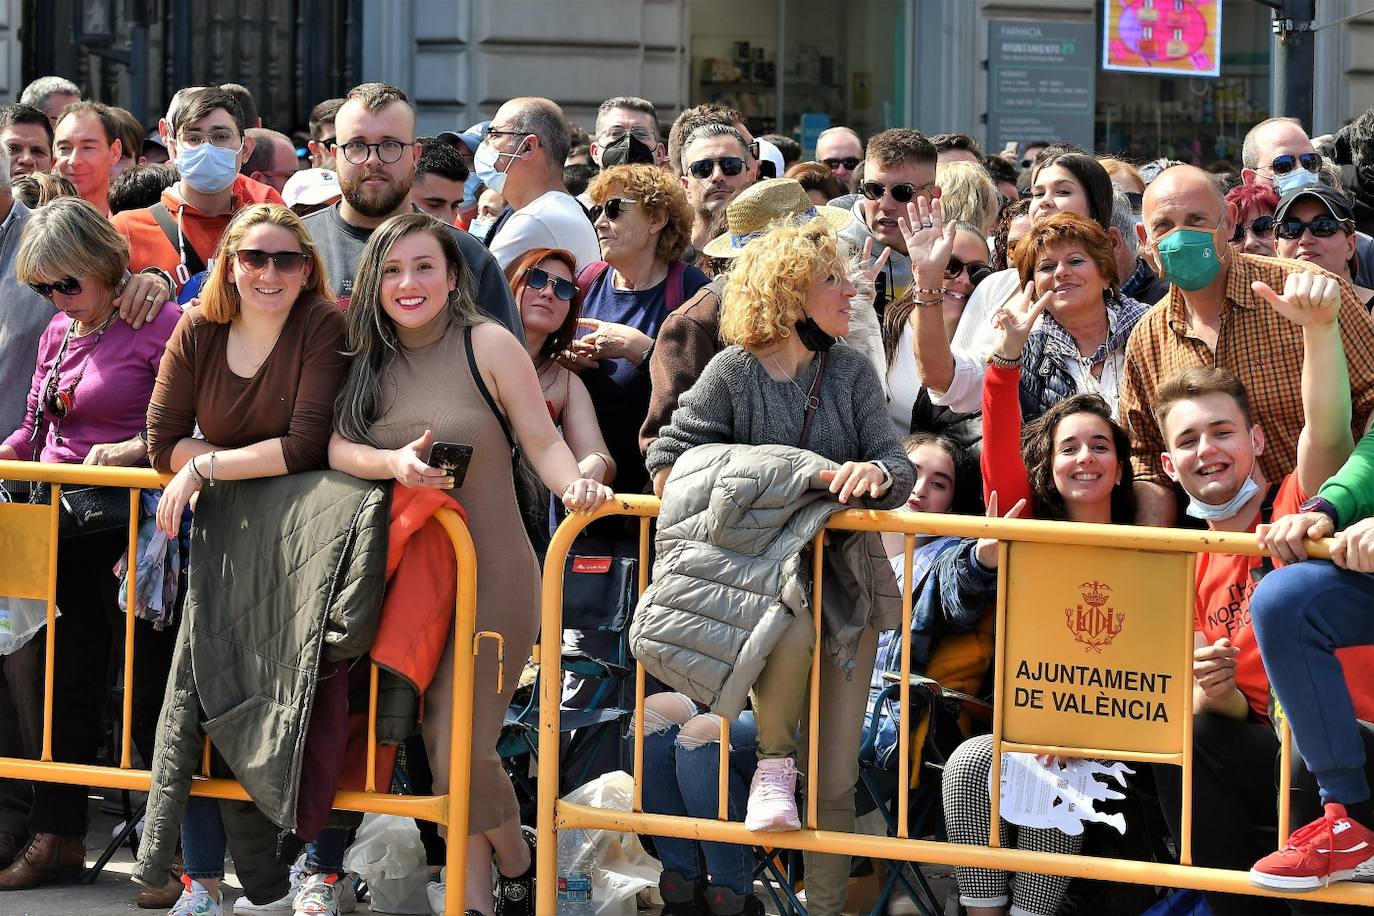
644 694 758 895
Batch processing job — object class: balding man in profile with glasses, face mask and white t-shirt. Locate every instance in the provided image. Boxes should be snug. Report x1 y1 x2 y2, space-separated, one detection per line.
474 98 600 271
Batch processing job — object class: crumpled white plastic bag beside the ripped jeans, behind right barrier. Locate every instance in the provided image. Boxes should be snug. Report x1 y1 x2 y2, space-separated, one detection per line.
560 770 664 916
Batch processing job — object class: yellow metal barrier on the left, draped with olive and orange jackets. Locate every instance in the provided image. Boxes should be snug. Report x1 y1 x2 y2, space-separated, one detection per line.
0 461 477 913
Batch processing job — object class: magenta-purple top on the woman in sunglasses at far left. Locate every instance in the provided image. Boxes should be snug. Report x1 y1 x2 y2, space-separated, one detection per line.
4 302 181 464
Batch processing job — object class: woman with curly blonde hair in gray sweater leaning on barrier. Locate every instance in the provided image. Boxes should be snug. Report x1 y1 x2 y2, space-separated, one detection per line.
647 222 915 913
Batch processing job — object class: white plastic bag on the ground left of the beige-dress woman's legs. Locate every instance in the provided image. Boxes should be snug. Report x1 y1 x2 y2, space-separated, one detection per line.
344 814 430 916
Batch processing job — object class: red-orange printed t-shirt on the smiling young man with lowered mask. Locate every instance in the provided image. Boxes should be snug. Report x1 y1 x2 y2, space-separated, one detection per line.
1193 471 1374 721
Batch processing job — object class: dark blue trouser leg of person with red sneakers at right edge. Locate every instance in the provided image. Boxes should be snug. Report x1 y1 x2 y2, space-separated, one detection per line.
1250 560 1374 805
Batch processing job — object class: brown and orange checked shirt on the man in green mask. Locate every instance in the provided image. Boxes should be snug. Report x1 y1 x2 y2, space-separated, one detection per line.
1121 253 1374 486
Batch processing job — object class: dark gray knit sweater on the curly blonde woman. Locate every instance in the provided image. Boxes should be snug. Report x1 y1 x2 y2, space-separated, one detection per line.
646 341 916 508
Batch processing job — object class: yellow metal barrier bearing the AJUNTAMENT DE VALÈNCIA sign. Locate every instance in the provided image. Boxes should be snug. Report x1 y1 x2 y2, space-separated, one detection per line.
536 496 1374 915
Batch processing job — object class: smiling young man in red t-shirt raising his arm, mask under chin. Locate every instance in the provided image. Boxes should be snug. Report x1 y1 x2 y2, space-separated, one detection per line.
1154 273 1374 915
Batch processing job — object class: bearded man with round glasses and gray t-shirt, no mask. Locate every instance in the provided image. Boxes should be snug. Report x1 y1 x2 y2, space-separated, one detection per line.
305 82 519 333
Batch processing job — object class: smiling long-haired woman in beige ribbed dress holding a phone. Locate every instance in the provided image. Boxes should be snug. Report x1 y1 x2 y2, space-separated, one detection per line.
330 213 611 915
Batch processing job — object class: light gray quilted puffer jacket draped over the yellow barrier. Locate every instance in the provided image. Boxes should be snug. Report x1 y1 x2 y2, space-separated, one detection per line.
629 445 901 718
